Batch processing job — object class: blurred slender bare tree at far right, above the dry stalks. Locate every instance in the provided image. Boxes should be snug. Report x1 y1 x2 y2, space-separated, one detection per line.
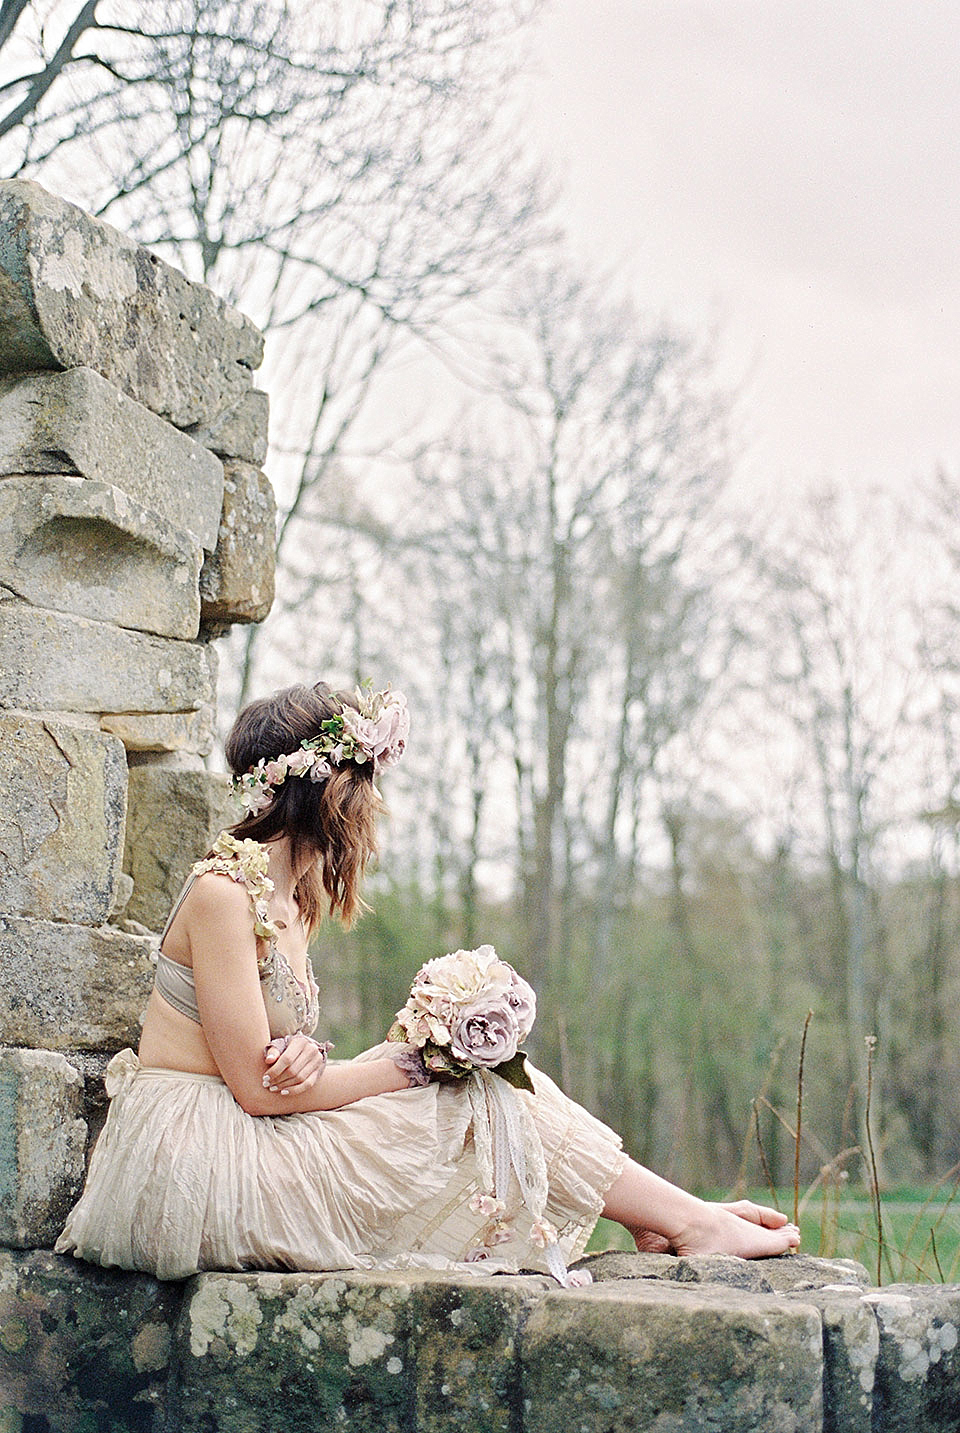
744 489 920 1169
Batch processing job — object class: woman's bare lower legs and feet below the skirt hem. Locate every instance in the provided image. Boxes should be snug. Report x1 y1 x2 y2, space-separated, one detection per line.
603 1159 800 1258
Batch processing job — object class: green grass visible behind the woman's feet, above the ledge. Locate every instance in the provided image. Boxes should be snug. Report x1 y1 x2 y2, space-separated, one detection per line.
587 1185 960 1284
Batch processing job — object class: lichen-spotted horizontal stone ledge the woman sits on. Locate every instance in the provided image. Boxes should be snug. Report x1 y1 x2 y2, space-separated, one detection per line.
0 1250 960 1433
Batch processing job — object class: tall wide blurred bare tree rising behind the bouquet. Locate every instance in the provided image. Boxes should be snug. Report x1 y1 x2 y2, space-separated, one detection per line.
330 265 722 1086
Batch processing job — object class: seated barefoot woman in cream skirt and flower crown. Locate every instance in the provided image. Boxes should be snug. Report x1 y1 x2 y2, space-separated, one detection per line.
56 684 800 1278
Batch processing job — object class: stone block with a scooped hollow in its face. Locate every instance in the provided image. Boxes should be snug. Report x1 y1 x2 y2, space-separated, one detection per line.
0 477 203 638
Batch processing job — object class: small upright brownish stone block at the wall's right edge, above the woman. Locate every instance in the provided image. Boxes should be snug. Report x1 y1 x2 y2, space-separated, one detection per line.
201 460 277 622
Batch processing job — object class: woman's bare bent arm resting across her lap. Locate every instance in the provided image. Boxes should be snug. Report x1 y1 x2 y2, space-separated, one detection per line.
185 873 408 1115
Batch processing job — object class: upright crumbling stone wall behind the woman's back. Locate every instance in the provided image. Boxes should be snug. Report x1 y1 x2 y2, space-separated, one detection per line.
0 181 275 1243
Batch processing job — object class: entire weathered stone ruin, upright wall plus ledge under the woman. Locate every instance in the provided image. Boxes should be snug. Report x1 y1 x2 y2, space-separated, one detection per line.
0 182 960 1433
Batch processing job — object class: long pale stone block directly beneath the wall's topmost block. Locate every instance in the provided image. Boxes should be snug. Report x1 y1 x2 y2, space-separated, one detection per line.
0 368 224 552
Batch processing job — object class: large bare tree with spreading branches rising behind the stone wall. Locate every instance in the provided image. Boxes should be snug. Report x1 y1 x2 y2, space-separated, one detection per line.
0 0 542 739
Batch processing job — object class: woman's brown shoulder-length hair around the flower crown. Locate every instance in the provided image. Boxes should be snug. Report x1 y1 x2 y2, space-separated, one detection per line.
226 682 383 933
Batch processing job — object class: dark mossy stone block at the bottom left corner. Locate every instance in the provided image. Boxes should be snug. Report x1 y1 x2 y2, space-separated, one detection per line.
0 1251 182 1433
